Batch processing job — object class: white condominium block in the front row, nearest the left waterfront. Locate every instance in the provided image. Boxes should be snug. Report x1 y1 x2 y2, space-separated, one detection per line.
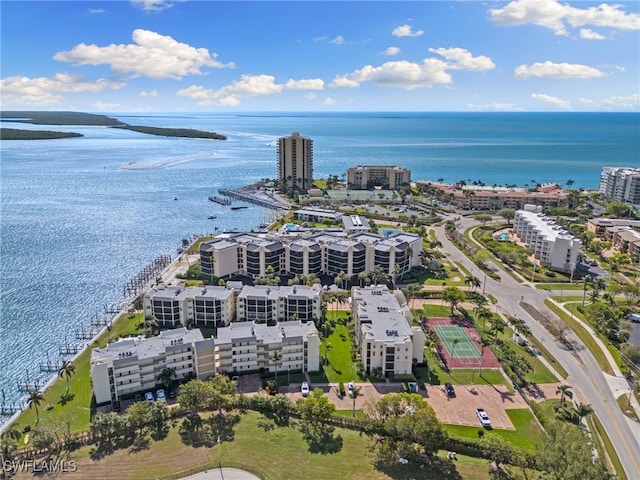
91 328 215 405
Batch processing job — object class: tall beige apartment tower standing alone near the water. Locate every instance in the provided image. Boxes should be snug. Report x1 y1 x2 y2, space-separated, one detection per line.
278 132 313 190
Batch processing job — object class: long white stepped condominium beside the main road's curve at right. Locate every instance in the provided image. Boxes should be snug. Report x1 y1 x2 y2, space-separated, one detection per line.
513 205 582 273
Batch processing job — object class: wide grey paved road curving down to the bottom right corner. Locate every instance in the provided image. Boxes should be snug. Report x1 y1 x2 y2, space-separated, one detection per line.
435 217 640 479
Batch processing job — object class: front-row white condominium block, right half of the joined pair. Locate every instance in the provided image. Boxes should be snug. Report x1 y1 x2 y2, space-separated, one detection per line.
215 321 320 373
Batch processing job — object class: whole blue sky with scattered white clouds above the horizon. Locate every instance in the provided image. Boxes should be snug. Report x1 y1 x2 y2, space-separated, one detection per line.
0 0 640 112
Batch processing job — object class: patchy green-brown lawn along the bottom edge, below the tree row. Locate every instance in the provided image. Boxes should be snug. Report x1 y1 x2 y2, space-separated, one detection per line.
57 412 489 480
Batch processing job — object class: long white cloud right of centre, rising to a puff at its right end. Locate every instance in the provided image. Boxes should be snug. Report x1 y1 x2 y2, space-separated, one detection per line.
331 48 495 90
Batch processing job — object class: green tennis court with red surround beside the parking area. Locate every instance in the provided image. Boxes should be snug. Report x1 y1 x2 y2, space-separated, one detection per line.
426 317 500 368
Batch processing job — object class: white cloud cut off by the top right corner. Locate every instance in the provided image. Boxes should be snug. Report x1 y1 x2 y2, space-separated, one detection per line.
489 0 640 35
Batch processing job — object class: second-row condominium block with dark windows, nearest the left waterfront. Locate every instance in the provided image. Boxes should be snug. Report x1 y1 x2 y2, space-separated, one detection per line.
143 285 236 328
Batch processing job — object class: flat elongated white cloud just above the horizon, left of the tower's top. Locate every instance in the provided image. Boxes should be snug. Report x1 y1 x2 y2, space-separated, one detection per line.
176 75 324 106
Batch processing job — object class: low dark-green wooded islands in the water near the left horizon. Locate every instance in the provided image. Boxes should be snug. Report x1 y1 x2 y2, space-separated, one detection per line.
0 111 227 140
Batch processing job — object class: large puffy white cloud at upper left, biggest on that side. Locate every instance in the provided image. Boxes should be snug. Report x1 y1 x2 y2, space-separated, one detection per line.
53 29 235 80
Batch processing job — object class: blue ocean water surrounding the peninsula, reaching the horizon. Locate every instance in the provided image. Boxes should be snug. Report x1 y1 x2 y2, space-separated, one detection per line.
0 113 640 422
